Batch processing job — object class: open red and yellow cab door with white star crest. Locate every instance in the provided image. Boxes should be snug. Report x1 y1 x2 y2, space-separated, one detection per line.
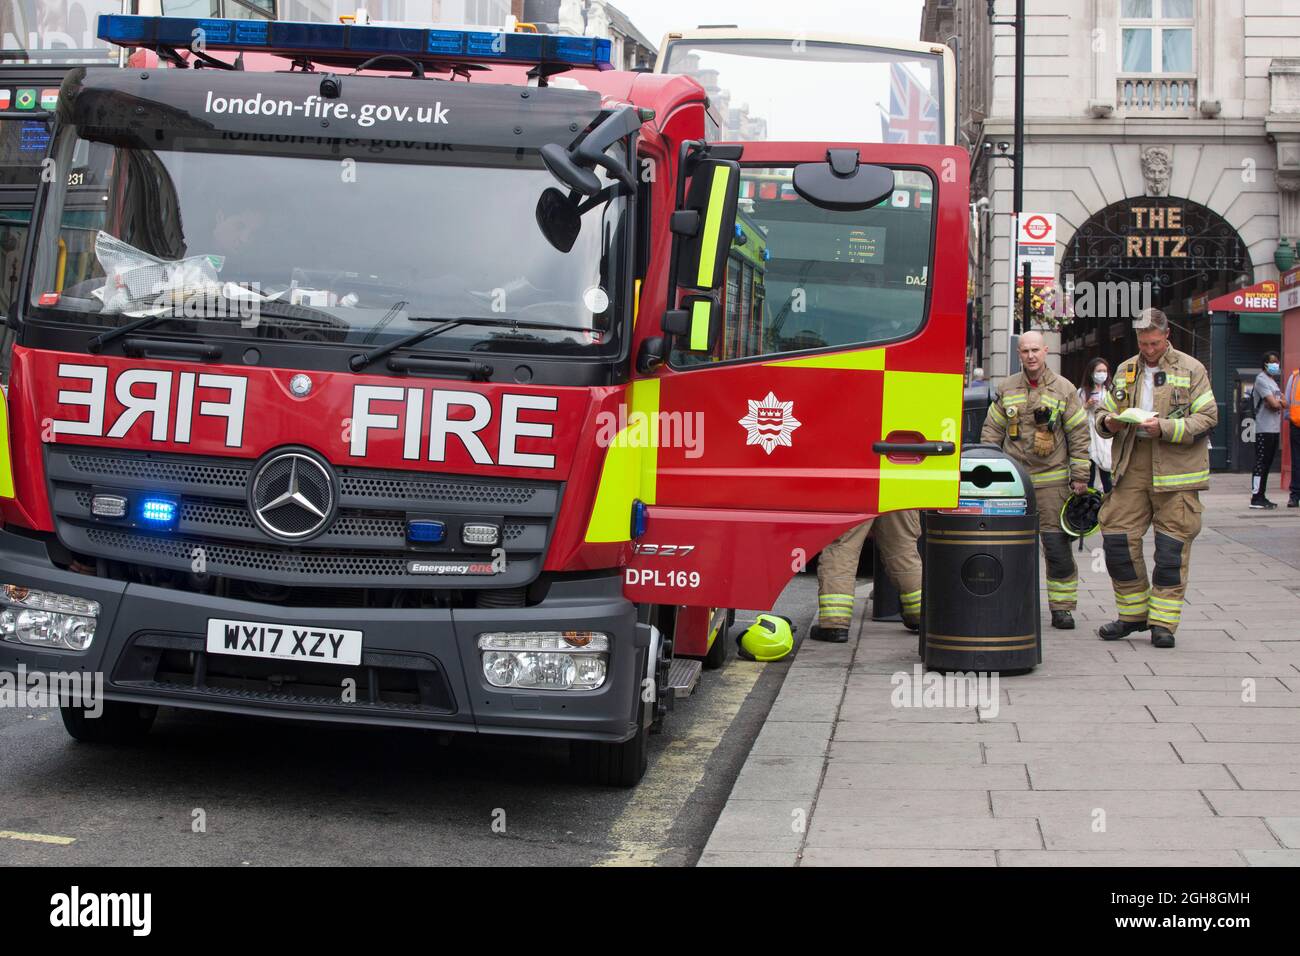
598 143 969 607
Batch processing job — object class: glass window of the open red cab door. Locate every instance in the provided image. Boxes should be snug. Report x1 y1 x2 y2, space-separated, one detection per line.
670 166 935 368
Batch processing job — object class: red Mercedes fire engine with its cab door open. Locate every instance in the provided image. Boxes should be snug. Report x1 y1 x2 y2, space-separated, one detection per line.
0 16 967 786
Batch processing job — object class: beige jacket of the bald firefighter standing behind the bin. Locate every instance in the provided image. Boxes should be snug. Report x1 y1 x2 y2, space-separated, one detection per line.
980 368 1091 488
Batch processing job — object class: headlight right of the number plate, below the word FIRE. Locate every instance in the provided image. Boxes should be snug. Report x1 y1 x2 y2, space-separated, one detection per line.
478 631 610 691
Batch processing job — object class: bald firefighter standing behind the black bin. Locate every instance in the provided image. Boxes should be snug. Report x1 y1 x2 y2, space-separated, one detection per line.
980 332 1092 631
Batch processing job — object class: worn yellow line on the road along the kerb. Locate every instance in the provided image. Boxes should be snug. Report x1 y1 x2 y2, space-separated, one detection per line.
597 658 763 866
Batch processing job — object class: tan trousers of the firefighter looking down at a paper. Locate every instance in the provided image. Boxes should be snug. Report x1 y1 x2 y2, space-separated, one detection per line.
1100 438 1203 632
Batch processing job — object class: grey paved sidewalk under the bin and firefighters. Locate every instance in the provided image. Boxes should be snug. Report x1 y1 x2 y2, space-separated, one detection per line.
699 476 1300 866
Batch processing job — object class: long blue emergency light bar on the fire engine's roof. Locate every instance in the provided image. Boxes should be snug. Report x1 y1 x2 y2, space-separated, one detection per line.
99 13 612 70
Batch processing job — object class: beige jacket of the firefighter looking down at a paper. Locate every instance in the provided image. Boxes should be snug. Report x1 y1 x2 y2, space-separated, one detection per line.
1097 347 1218 492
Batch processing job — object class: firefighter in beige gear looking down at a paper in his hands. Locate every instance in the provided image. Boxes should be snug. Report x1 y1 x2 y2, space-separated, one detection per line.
1097 308 1218 648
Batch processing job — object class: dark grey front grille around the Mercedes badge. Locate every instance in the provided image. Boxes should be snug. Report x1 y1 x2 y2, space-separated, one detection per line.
47 445 560 588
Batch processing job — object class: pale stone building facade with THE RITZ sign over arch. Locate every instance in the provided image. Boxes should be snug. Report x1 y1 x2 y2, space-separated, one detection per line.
922 0 1300 467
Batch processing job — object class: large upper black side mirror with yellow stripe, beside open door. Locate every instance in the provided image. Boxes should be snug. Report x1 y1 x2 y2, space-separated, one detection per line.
670 160 740 291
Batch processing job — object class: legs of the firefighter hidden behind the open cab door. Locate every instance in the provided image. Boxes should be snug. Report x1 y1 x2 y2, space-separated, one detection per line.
809 511 920 644
